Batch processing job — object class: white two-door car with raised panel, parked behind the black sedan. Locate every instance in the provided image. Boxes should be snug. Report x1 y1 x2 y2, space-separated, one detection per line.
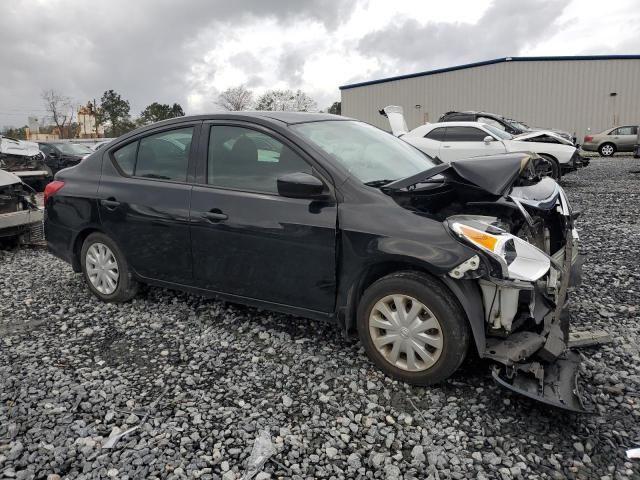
384 106 585 179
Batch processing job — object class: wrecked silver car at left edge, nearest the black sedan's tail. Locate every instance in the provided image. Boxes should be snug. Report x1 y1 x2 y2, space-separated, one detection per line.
0 170 43 243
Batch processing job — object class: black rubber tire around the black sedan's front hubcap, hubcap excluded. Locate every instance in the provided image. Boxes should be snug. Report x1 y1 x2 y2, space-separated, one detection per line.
357 272 470 386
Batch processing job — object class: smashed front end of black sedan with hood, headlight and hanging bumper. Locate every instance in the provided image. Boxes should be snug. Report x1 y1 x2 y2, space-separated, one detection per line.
387 153 586 412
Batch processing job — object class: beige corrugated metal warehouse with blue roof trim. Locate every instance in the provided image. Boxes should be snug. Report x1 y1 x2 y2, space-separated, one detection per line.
340 55 640 141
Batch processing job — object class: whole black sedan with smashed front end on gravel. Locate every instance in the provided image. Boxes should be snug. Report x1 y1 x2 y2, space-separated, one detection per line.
45 112 581 410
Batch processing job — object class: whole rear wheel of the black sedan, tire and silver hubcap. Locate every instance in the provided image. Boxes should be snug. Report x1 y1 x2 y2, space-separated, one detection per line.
80 232 138 302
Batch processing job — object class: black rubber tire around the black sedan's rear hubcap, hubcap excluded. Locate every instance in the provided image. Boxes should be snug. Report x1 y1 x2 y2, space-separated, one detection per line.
80 232 138 303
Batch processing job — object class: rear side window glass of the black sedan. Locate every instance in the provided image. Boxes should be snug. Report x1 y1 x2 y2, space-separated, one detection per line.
113 127 193 182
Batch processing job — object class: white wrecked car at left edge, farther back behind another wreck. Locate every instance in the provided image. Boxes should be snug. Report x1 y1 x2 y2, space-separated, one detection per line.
0 135 53 191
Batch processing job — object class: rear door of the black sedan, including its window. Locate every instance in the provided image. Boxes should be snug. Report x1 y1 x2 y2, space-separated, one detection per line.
98 123 200 284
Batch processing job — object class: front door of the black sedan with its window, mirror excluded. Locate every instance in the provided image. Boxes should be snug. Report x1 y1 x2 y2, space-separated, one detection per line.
191 122 337 313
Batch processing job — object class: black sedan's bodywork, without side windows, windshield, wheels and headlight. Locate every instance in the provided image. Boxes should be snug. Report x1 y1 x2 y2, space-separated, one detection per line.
45 112 592 412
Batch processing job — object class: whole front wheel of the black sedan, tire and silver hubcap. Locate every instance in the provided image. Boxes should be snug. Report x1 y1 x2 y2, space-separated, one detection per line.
358 272 469 385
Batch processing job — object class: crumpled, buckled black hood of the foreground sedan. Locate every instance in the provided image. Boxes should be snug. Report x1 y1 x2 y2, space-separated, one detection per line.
383 152 535 195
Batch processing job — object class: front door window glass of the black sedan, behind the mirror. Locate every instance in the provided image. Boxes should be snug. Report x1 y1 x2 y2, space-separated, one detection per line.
207 125 312 194
